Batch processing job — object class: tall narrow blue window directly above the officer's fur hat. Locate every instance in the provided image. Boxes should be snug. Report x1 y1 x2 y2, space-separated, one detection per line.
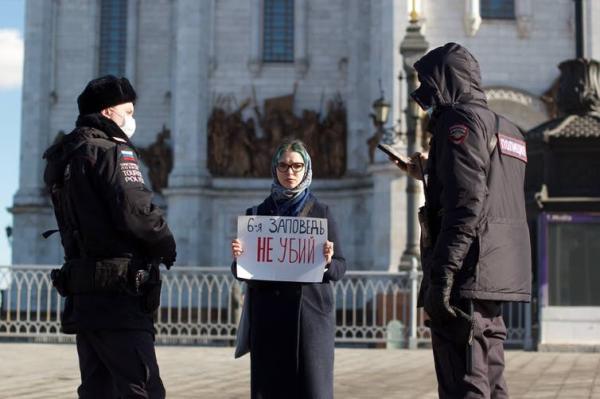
98 0 127 76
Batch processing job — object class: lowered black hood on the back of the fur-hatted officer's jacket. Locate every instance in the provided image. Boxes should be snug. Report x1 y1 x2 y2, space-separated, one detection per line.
44 113 135 187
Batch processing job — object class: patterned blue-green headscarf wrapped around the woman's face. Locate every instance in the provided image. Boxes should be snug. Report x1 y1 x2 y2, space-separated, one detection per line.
271 140 312 216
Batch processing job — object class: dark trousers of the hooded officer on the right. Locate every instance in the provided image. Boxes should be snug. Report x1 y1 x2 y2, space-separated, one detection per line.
431 300 508 399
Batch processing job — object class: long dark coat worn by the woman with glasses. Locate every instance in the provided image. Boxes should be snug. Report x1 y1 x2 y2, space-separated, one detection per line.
232 197 346 399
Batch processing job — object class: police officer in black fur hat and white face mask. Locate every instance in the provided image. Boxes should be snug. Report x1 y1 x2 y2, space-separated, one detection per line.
44 75 176 399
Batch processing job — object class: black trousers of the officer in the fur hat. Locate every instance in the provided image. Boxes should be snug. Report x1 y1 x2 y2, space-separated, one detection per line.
77 330 165 399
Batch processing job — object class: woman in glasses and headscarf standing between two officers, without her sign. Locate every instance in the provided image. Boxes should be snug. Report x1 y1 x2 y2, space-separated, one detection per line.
231 140 346 399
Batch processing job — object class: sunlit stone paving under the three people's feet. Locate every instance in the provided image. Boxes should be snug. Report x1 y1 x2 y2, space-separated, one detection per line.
0 343 600 399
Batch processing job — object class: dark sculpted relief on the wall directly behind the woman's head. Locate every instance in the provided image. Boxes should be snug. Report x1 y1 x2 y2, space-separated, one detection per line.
208 89 347 177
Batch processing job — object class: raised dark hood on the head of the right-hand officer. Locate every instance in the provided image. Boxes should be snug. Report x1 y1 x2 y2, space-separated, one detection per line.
411 43 487 109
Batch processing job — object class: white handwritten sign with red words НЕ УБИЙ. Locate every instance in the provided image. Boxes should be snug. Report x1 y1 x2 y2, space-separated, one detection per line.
237 216 327 283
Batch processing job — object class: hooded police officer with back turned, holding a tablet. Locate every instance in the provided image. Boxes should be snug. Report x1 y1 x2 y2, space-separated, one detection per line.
398 43 531 398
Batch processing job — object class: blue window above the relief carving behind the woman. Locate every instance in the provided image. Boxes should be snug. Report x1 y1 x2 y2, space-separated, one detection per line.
263 0 294 62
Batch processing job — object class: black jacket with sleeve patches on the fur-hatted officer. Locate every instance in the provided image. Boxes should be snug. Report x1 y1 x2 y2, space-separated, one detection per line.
44 114 175 332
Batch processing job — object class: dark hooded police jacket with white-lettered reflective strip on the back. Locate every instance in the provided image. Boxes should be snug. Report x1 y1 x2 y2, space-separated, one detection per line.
413 43 531 301
